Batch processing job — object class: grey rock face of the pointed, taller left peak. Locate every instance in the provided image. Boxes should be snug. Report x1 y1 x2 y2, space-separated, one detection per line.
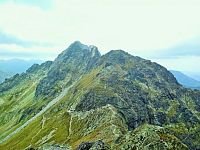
35 41 100 98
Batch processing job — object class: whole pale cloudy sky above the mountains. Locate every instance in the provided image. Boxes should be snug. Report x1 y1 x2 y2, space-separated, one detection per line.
0 0 200 73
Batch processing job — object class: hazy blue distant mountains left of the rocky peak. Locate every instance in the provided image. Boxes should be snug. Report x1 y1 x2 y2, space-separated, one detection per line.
0 59 42 74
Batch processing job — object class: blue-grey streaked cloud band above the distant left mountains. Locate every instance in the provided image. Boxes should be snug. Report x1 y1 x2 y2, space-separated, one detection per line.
0 32 58 60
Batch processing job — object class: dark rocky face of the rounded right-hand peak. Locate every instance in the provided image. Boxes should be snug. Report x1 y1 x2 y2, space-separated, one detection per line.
76 50 200 130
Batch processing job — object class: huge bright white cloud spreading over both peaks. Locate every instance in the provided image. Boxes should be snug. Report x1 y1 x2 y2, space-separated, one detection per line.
0 0 200 71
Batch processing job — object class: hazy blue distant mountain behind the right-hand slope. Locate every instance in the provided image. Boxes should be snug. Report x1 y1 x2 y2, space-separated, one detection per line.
170 70 200 89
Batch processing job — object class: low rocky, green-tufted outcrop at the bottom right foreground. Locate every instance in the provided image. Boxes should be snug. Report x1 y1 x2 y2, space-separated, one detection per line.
115 124 188 150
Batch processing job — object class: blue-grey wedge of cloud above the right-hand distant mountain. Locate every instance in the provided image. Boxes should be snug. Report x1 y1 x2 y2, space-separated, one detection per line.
148 37 200 75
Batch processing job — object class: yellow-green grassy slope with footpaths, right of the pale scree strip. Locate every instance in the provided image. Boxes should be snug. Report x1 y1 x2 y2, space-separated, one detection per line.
0 67 123 149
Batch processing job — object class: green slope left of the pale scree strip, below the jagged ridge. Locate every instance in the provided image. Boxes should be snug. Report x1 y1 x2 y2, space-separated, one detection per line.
0 65 52 140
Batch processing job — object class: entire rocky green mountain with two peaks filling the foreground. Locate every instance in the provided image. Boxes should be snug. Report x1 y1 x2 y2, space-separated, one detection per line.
0 41 200 150
